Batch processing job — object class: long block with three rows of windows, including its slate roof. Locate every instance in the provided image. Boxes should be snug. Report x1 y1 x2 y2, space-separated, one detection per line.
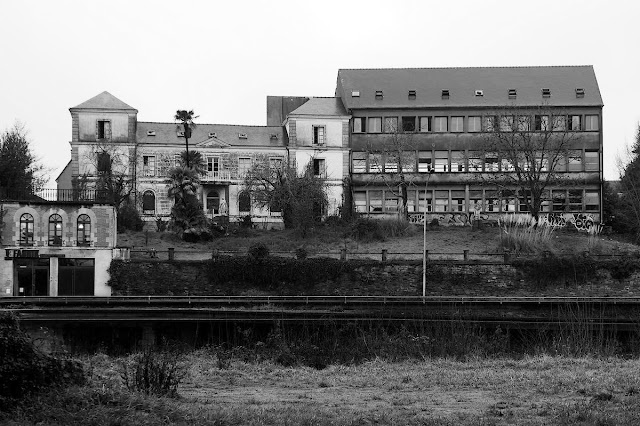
336 66 603 228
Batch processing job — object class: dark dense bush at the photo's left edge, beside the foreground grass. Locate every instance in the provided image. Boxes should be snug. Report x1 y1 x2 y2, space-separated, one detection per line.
0 313 85 410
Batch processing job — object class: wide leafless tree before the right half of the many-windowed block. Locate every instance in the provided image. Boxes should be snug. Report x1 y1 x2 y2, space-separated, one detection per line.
476 105 581 219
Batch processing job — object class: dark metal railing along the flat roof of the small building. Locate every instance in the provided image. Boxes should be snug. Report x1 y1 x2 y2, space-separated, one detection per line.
0 188 113 204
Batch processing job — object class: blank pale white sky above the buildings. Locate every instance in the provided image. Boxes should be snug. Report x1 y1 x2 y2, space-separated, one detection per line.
0 0 640 182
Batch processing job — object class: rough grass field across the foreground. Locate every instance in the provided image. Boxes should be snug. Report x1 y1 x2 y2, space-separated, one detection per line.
0 350 640 426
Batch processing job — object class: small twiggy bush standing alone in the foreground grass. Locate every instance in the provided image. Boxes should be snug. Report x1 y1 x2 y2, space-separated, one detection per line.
120 348 185 397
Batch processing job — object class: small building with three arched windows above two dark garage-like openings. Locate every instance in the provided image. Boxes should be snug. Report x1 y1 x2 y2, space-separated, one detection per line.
0 190 117 297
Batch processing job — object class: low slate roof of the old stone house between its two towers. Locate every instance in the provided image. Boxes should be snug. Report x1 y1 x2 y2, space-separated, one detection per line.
136 121 286 147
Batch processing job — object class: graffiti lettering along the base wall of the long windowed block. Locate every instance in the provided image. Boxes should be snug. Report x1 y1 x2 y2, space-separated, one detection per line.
409 212 597 231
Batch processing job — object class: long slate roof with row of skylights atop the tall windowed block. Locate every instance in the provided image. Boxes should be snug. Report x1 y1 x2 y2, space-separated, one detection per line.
336 65 602 111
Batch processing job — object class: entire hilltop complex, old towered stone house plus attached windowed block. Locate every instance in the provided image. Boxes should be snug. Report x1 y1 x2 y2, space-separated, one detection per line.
58 66 603 228
